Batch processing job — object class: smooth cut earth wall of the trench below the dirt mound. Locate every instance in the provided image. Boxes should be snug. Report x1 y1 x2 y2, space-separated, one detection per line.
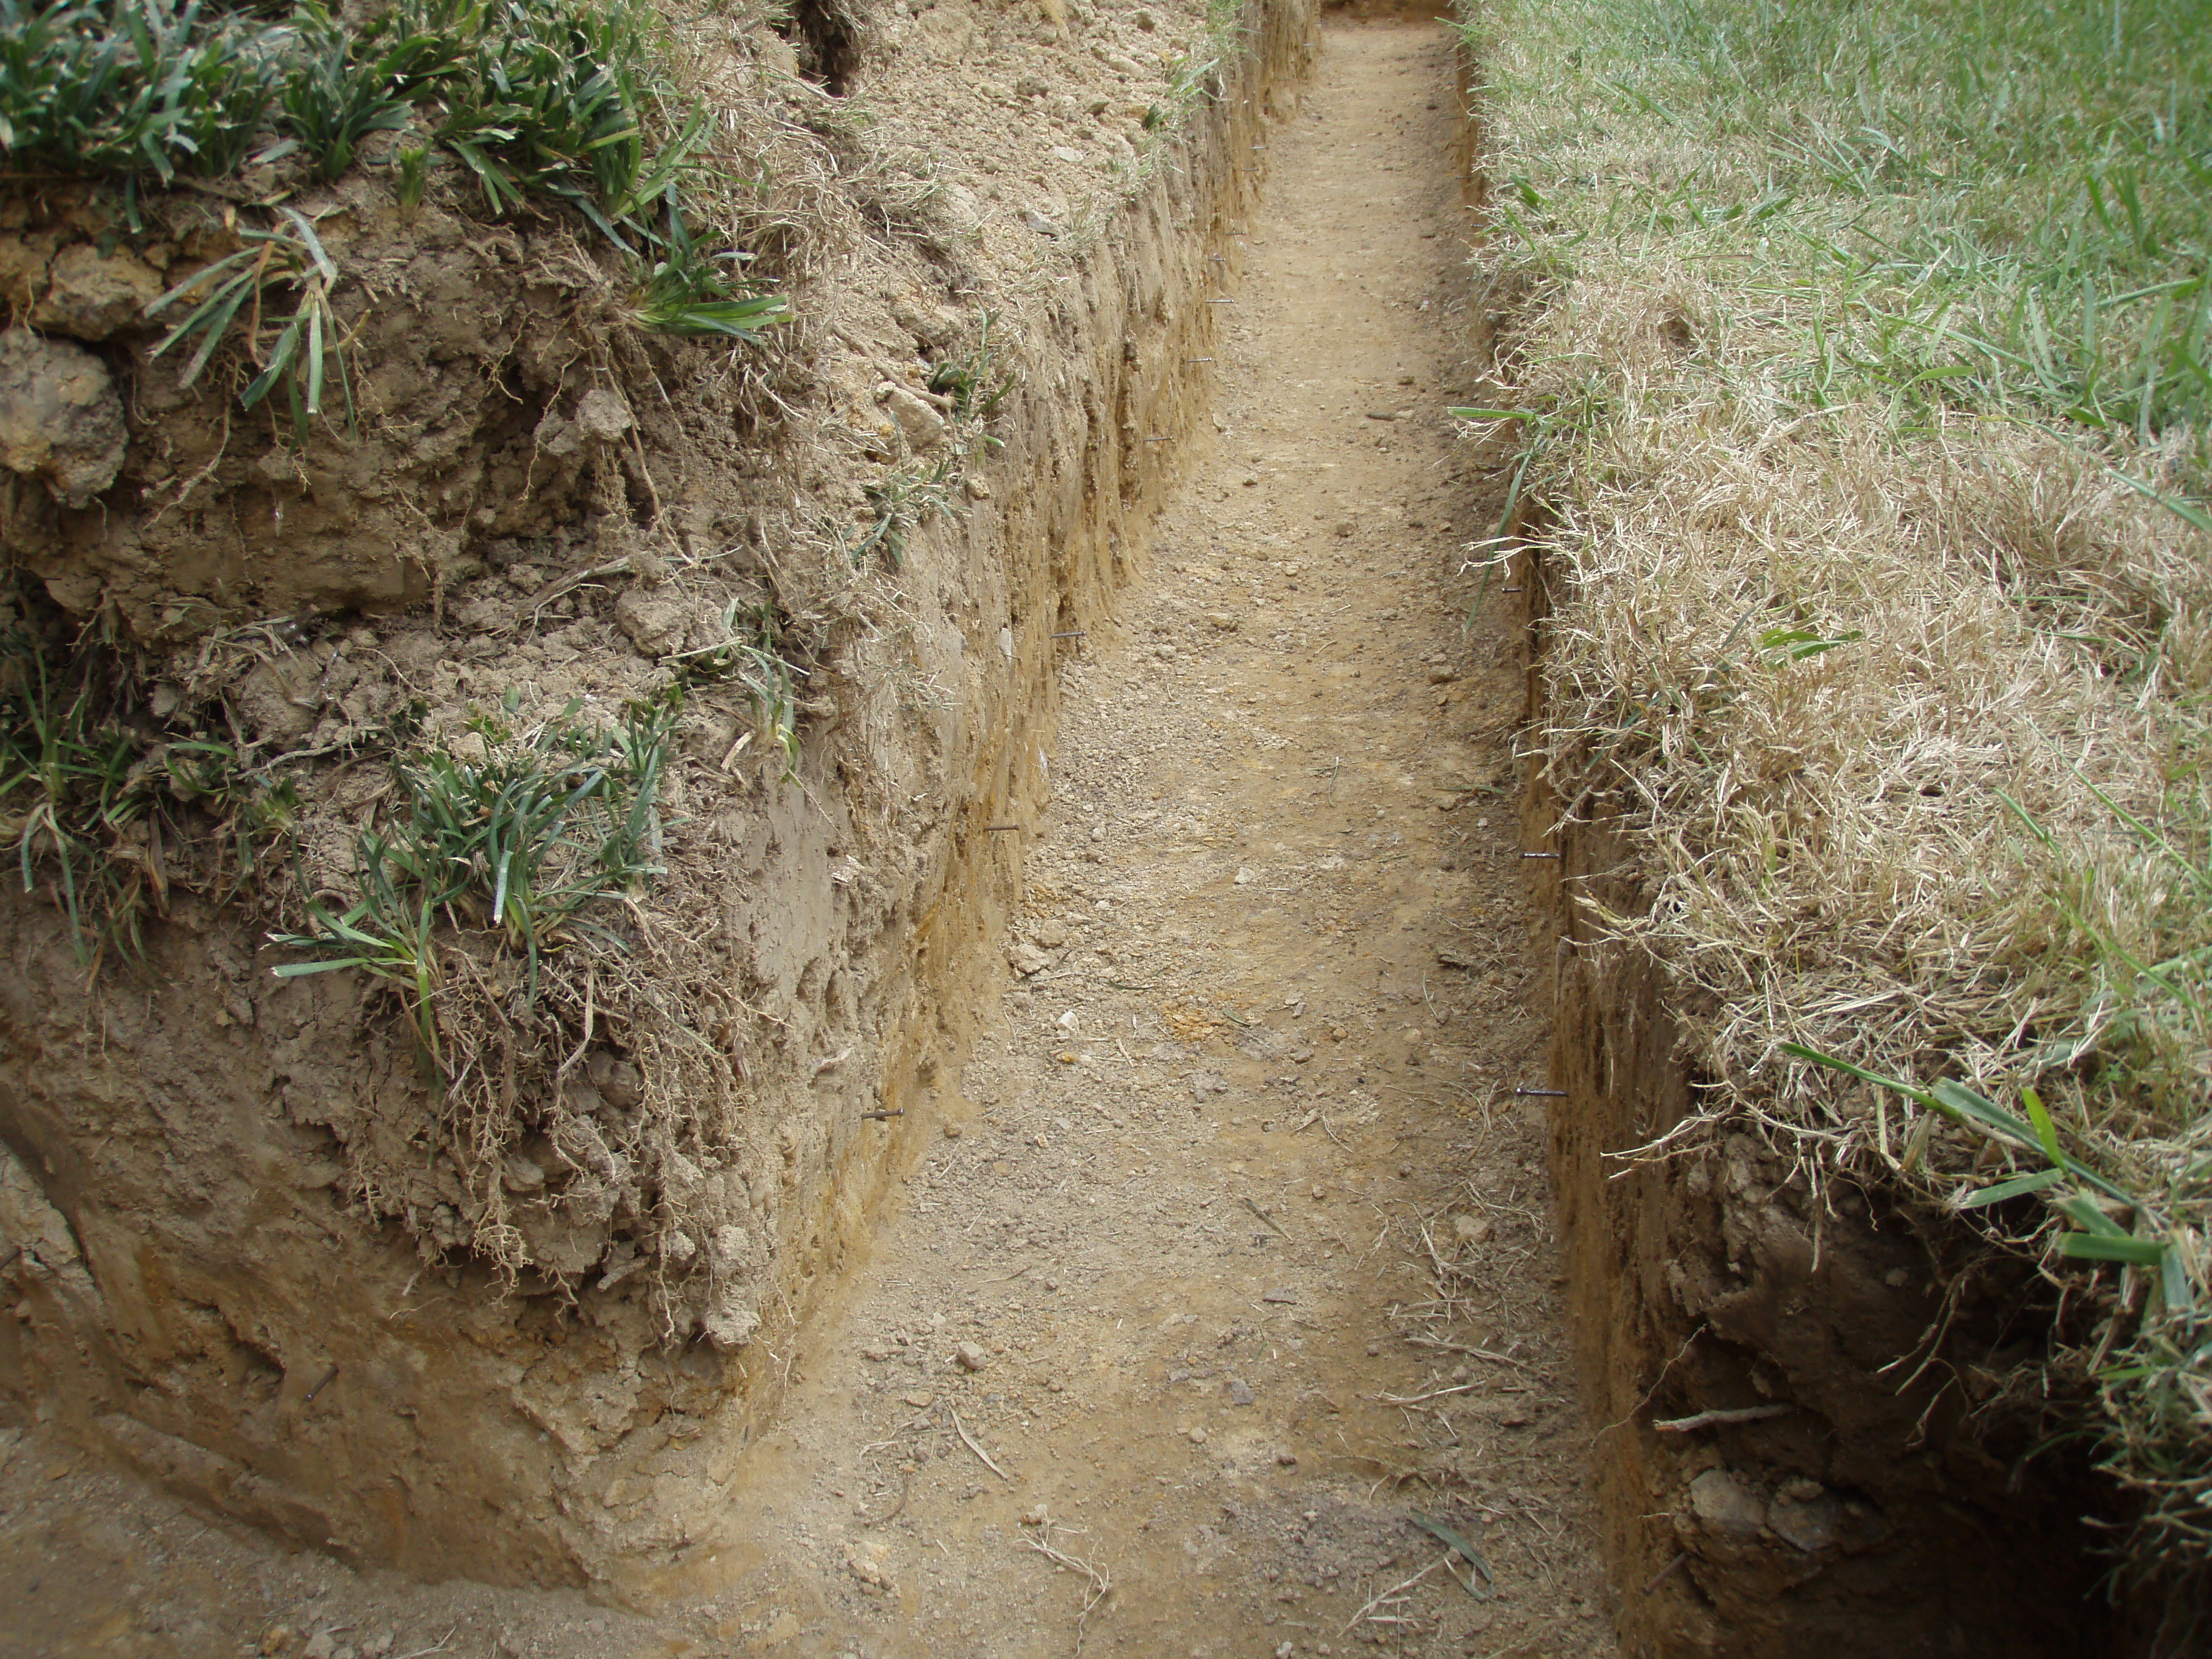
0 0 1316 1597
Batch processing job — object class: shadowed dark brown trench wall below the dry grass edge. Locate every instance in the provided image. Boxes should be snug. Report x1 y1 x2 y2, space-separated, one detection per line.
1515 535 2128 1659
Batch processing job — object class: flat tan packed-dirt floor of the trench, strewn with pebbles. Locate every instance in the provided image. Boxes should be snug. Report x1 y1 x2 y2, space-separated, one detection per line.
0 24 1615 1659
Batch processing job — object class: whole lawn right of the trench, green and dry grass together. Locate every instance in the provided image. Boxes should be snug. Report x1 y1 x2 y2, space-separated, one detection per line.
1469 0 2212 1573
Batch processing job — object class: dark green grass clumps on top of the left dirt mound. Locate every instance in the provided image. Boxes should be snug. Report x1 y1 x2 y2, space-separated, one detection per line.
0 0 788 442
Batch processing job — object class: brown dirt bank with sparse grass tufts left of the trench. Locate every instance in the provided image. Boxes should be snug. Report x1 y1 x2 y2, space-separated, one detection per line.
0 0 1310 1579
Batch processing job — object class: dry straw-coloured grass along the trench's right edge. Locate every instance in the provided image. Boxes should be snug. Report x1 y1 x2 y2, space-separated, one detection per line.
1484 4 2212 1566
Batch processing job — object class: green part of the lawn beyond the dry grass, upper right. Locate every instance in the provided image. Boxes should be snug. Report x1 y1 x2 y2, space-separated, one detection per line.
1468 0 2212 480
